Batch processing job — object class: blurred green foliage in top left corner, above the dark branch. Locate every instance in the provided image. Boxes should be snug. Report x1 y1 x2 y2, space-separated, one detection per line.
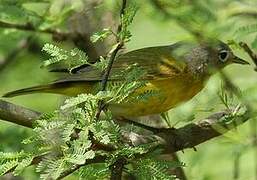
0 0 85 30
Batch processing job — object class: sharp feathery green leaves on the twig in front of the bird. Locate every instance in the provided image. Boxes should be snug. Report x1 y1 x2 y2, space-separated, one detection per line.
0 4 167 179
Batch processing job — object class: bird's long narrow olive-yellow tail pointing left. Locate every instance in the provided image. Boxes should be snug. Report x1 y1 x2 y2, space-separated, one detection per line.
3 81 93 98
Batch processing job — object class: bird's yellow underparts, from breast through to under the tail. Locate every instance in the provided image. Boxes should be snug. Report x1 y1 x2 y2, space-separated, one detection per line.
49 73 204 117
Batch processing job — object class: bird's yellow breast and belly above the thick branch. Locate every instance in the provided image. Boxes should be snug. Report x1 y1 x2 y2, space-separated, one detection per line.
109 76 204 117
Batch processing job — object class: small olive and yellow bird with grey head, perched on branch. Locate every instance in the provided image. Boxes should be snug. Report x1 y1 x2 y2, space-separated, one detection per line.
3 41 249 118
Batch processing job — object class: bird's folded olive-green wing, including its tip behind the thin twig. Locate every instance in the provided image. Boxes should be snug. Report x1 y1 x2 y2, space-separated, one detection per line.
54 43 186 82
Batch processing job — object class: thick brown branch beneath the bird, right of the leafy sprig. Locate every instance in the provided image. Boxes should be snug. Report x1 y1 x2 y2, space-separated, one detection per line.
122 111 250 153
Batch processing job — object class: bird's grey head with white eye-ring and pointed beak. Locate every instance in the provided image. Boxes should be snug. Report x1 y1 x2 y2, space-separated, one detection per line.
183 41 249 75
